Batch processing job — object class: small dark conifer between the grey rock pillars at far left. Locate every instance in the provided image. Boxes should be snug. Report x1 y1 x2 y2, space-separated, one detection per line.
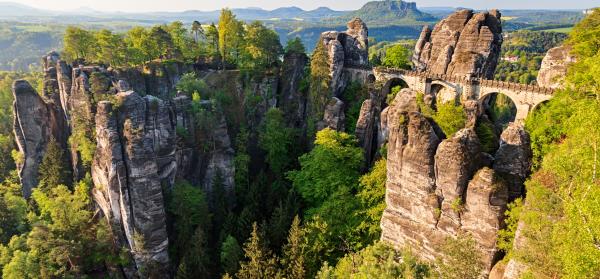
38 137 70 193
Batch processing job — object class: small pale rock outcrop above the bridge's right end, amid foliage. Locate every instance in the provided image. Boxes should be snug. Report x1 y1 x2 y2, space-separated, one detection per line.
537 45 576 88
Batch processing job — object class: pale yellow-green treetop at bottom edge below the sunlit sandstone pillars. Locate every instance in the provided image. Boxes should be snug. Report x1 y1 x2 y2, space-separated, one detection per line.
435 234 485 279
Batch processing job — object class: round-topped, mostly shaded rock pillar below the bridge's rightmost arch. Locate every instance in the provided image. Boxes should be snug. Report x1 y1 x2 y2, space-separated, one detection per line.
494 123 533 200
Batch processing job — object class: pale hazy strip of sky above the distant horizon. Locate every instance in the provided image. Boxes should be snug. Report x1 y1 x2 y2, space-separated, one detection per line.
11 0 600 12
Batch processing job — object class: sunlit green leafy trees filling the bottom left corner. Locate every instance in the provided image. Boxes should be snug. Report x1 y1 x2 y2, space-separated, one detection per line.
1 178 116 278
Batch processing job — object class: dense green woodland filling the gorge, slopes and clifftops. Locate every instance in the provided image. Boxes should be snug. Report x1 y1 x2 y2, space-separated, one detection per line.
0 5 600 278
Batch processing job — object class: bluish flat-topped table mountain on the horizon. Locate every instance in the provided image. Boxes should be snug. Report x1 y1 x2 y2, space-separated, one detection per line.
338 0 437 25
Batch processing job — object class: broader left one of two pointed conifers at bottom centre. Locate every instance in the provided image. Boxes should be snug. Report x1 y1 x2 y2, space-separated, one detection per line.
236 223 278 279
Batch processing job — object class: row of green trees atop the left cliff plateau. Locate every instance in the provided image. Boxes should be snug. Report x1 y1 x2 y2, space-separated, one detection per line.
63 9 283 72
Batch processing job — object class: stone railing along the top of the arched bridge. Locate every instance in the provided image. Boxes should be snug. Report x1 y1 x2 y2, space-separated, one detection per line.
375 67 554 95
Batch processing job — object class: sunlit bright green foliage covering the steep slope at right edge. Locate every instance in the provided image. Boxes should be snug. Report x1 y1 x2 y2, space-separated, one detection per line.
507 10 600 278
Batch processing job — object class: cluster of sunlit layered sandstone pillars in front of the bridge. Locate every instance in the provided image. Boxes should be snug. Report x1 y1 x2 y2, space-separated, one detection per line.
380 89 531 276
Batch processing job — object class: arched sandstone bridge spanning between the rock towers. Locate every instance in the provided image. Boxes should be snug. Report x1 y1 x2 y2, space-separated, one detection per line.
369 67 554 121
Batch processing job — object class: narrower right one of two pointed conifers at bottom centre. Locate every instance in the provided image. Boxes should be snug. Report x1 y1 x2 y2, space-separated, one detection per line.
281 215 306 279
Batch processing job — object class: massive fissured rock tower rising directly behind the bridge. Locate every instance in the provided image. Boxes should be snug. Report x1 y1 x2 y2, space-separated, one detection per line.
412 10 502 79
